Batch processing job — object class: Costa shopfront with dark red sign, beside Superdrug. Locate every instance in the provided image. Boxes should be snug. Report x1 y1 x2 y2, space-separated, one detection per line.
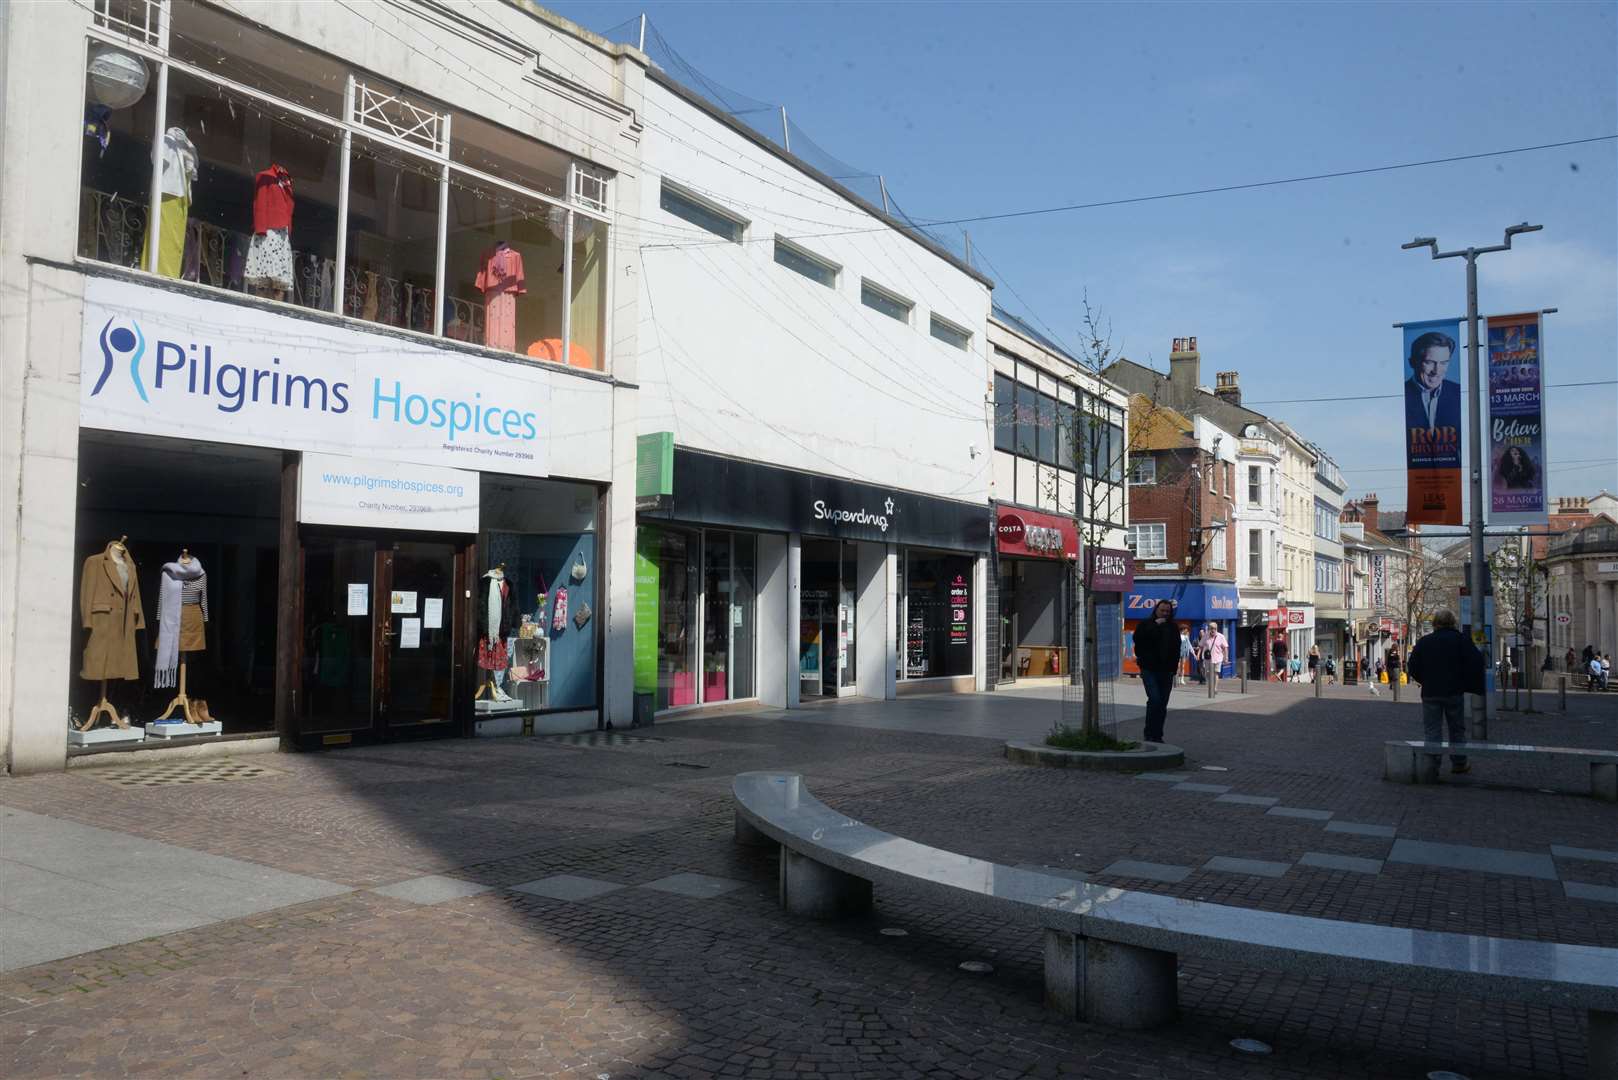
995 505 1079 683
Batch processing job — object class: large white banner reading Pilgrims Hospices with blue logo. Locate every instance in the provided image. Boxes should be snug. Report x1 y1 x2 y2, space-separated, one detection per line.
79 279 555 476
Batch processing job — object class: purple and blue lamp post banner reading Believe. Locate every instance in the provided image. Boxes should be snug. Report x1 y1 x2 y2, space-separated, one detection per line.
1487 314 1550 525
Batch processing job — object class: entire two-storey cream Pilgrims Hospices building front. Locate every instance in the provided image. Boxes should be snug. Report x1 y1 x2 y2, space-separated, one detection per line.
0 0 644 772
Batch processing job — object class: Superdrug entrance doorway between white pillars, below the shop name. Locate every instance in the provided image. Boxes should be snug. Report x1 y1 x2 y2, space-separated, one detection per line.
798 539 859 698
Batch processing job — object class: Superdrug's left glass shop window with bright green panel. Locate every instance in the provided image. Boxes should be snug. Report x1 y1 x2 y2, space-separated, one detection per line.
636 525 757 711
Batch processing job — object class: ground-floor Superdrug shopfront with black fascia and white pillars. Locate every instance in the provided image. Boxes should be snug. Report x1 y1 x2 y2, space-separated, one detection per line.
634 447 990 712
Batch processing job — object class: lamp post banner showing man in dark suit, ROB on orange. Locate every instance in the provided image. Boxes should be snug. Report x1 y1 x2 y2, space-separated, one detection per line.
1401 319 1461 525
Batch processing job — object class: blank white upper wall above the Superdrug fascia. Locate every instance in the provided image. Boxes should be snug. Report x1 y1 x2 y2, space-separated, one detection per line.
626 81 992 502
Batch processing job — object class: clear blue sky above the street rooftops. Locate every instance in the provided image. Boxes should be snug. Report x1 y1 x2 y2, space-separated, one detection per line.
550 3 1618 508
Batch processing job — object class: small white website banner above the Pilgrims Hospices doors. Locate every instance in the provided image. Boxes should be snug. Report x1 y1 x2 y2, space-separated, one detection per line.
298 452 477 534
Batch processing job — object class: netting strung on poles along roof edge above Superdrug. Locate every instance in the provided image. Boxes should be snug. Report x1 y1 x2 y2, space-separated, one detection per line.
600 16 972 266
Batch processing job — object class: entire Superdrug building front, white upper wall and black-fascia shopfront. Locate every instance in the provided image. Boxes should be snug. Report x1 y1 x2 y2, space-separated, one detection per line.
633 73 992 714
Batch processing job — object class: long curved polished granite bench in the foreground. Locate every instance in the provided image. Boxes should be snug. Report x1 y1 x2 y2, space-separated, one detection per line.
731 772 1618 1080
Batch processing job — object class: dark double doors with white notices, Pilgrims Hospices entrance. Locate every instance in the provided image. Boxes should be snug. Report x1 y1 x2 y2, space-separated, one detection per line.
294 533 469 745
